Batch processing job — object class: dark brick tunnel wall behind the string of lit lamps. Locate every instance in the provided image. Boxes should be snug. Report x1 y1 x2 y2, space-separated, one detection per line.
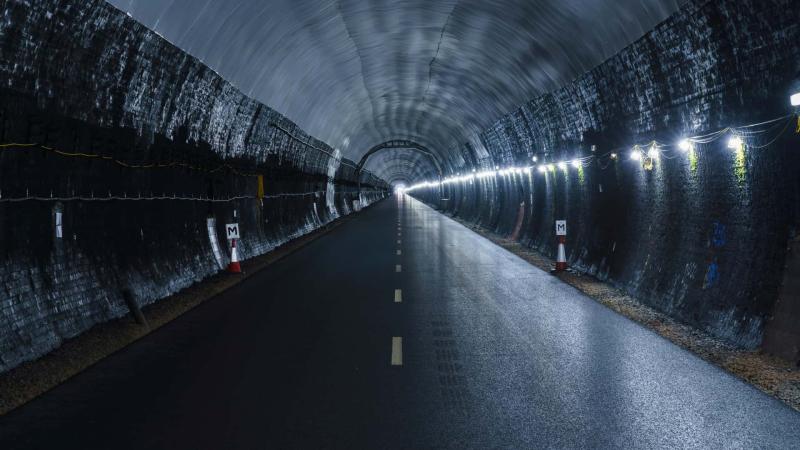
414 0 800 347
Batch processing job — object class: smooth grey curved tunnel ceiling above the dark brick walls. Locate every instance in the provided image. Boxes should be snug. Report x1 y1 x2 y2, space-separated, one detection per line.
104 0 682 183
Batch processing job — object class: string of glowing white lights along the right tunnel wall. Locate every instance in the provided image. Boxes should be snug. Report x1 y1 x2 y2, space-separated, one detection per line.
403 114 800 192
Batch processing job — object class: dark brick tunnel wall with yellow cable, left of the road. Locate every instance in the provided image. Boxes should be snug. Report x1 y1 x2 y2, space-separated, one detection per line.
0 0 388 372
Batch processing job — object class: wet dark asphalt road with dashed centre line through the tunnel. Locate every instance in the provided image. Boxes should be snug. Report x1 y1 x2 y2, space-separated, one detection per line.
0 197 800 449
